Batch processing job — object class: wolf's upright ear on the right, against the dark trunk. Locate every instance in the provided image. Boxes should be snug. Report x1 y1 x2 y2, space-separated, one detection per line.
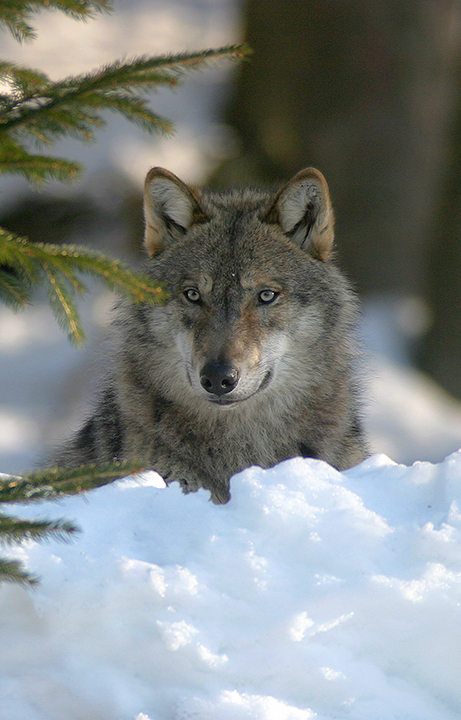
266 168 334 260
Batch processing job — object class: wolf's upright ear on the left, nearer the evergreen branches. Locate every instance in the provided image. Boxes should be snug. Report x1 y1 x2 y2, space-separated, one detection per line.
144 168 207 256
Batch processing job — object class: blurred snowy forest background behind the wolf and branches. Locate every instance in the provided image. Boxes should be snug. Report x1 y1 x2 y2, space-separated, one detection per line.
0 0 461 472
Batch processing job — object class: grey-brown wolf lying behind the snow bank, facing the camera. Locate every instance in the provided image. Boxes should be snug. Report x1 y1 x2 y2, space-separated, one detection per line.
56 168 367 503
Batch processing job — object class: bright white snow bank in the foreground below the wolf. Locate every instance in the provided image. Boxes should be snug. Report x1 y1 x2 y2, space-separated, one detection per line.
0 451 461 720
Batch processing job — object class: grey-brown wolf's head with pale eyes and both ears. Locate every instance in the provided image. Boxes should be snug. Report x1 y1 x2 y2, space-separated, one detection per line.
144 168 353 407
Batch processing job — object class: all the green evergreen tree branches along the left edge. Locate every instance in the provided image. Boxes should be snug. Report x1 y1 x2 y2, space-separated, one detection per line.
0 0 246 584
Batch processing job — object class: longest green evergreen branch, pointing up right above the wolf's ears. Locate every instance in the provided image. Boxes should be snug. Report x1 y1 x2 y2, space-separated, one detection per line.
0 45 248 142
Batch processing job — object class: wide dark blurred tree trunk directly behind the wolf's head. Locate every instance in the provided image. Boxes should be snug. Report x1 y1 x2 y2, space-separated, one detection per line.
215 0 458 293
